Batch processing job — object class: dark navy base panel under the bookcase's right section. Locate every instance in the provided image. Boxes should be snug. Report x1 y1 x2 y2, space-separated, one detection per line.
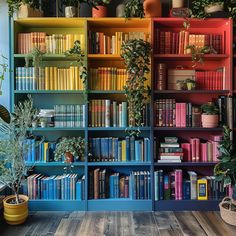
154 200 220 211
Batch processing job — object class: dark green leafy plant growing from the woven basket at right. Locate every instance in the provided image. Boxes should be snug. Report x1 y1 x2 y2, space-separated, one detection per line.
214 126 236 201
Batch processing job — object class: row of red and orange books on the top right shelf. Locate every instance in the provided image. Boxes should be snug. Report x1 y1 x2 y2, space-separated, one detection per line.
154 29 224 54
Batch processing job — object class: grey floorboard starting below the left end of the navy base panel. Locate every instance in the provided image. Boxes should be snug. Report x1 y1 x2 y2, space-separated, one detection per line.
153 211 183 236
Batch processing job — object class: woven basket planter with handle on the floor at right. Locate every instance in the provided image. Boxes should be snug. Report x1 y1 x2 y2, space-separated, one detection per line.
219 197 236 226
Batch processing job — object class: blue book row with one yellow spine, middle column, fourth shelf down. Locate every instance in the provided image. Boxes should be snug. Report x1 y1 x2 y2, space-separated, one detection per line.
89 136 151 162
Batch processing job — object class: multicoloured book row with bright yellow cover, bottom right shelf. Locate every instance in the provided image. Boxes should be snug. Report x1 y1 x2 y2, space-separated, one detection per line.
154 169 226 201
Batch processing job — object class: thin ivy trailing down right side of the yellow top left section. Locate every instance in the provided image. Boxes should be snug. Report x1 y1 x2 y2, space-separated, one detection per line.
64 40 88 101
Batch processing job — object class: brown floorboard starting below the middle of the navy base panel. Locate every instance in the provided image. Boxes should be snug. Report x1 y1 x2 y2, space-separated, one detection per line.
174 211 207 236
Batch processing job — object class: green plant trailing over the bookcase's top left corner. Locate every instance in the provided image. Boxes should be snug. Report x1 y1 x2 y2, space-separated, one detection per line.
6 0 40 17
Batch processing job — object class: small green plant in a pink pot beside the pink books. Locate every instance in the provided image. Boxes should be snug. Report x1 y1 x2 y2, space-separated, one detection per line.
201 102 219 128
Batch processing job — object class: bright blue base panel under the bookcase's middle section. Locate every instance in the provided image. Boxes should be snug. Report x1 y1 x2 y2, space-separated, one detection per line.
88 198 152 211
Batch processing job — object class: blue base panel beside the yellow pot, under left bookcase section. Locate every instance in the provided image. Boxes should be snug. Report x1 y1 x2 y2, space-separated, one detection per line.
29 200 86 211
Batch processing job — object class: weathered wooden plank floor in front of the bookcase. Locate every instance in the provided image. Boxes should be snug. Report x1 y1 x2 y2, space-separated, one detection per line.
0 212 236 236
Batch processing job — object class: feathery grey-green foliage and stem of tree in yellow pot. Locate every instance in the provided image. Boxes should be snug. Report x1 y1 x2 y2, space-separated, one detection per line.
0 95 35 204
